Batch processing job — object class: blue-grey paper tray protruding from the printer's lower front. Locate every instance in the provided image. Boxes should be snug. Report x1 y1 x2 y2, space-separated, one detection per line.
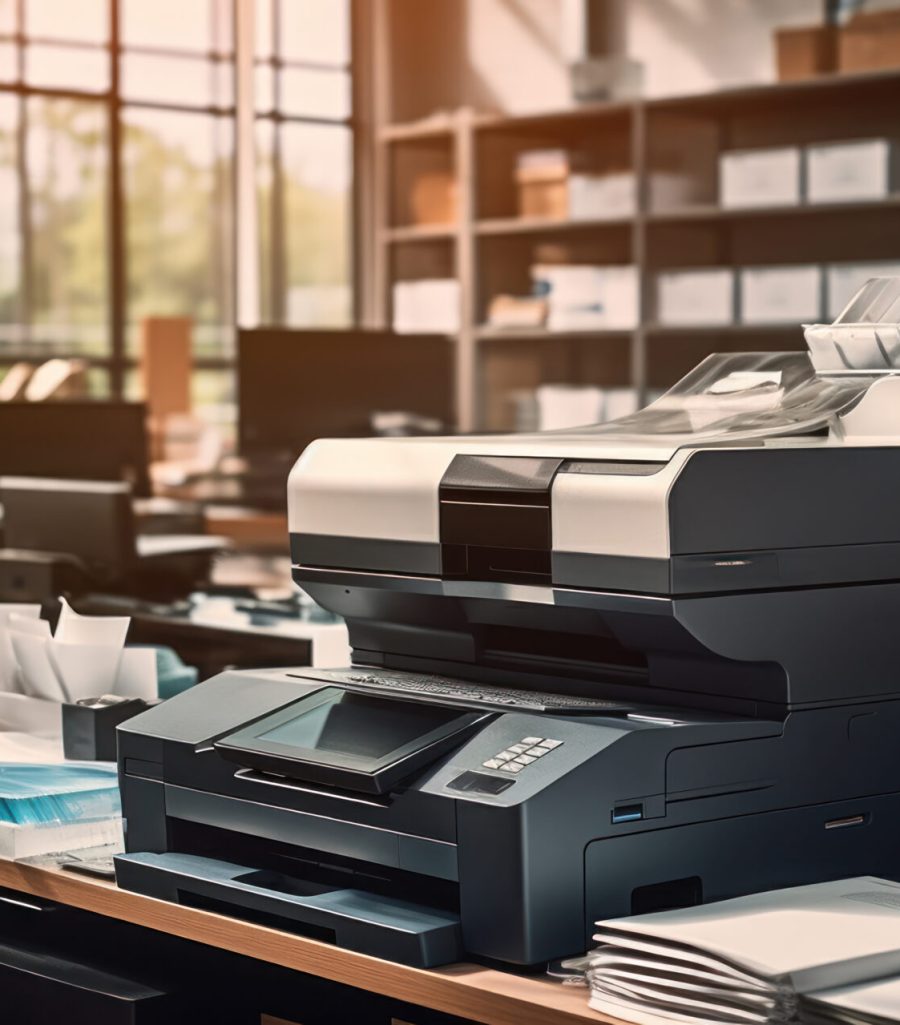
116 853 462 968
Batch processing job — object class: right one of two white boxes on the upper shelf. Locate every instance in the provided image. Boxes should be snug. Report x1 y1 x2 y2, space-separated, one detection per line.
807 138 894 203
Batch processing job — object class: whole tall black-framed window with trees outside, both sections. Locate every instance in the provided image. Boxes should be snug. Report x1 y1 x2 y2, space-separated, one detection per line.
0 0 353 402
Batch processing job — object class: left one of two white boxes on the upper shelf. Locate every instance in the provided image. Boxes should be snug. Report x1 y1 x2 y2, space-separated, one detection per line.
719 146 801 209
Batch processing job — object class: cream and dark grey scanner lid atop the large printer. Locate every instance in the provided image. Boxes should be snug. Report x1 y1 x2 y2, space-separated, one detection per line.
288 279 900 589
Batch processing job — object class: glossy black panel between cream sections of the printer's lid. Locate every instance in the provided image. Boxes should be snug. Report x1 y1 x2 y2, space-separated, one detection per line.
440 455 563 584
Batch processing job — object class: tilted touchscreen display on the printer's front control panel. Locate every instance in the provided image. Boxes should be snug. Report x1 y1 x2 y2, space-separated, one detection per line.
256 688 460 760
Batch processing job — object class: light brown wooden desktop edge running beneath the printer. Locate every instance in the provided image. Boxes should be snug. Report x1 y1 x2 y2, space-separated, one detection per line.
0 859 612 1025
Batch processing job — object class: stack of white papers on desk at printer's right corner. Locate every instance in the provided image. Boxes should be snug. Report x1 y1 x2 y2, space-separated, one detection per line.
586 876 900 1025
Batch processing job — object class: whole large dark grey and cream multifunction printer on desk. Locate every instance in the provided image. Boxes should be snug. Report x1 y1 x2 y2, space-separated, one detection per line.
117 280 900 966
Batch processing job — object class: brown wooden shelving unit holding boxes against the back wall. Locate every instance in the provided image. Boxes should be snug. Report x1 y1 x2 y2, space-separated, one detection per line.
376 64 900 431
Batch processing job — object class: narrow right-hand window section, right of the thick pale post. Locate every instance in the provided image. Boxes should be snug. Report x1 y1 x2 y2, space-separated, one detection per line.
254 0 353 327
